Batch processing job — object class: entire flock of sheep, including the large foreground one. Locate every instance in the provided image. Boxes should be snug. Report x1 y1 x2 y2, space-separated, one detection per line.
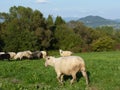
0 49 88 85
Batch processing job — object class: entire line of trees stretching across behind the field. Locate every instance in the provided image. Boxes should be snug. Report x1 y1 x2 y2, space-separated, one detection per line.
0 6 120 52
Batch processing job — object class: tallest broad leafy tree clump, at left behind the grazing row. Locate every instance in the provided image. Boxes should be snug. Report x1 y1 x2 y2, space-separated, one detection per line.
0 6 49 52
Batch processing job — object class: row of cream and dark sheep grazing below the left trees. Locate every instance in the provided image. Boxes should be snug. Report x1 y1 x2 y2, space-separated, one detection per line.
0 50 47 60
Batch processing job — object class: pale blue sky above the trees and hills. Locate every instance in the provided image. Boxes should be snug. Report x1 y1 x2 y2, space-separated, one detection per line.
0 0 120 19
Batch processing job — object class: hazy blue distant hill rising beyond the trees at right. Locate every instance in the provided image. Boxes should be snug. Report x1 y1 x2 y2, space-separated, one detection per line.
78 16 120 28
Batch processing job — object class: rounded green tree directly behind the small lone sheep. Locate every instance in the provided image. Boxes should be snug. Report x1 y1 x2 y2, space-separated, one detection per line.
55 25 81 52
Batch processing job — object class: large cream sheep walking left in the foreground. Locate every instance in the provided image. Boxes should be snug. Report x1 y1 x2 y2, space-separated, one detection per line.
45 56 88 85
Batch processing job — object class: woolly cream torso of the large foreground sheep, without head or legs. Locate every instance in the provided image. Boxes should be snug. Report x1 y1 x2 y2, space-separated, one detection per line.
55 56 84 75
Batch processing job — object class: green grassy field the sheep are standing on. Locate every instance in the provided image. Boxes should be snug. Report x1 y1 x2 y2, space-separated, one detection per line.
0 51 120 90
